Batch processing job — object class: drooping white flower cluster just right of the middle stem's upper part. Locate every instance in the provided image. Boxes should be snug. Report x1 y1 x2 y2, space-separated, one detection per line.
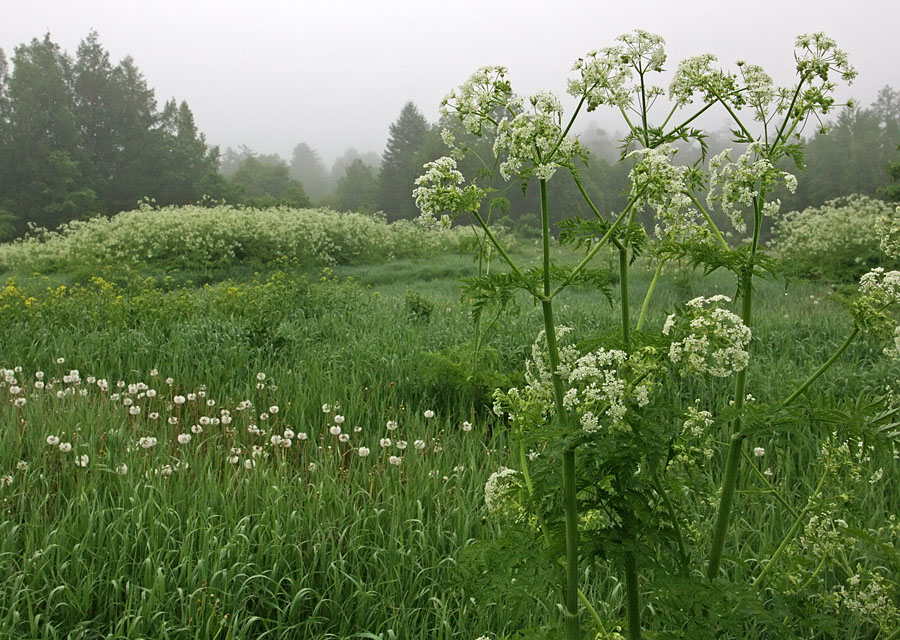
628 144 702 239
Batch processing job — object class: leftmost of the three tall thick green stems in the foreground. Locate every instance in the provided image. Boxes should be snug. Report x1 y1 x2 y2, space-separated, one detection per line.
540 180 581 640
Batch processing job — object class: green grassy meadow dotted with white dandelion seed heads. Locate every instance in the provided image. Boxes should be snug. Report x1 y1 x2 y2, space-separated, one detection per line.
0 236 900 640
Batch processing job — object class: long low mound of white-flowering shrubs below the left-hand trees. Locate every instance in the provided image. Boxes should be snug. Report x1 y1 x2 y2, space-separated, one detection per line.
0 206 510 271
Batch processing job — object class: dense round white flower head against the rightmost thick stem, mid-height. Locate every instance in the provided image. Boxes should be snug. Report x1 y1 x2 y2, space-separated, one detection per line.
663 295 750 378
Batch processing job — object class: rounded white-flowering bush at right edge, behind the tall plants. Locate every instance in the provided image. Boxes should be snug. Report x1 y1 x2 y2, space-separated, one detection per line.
773 194 900 281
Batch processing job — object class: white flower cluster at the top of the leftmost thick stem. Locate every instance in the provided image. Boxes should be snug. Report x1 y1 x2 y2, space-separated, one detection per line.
494 91 580 180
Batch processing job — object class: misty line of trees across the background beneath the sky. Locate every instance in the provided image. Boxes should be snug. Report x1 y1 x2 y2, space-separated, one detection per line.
0 32 900 240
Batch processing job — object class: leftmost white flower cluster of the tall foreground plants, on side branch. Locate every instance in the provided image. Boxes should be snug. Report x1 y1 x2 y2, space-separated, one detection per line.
413 156 484 227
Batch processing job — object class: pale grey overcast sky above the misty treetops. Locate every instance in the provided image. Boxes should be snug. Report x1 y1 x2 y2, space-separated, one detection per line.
0 0 900 163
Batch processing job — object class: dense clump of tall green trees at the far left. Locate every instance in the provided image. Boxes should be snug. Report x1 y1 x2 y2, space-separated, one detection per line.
0 32 225 233
